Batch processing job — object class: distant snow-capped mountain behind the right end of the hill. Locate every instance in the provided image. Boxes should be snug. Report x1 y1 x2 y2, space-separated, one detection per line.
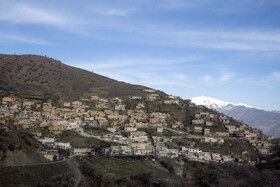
191 96 280 137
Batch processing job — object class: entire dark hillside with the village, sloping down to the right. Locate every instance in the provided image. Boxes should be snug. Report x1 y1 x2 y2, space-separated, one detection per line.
0 55 280 186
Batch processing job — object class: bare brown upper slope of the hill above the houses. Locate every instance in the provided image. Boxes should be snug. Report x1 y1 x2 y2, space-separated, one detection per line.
0 54 153 104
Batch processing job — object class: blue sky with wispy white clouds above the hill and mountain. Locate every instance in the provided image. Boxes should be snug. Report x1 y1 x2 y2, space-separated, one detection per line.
0 0 280 110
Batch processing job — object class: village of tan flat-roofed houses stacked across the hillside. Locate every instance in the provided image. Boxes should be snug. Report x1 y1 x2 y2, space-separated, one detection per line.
0 89 274 164
